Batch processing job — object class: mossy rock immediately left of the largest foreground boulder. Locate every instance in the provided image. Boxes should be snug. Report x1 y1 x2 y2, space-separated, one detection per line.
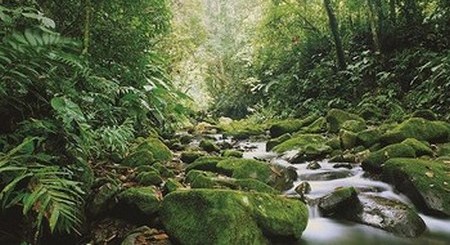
118 187 161 216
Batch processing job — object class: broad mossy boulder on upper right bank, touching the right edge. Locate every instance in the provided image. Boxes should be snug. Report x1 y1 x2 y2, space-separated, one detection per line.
381 118 450 144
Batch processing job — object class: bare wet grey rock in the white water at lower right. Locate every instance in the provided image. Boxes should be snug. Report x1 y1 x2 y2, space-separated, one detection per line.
350 195 426 237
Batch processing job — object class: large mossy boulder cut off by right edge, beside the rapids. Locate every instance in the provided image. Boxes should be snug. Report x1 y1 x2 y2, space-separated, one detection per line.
382 158 450 217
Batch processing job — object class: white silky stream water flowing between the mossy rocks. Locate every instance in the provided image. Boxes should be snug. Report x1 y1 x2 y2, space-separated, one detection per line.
232 141 450 245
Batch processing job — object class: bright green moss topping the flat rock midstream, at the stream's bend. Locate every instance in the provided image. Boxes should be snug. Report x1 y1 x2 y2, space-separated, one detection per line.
273 134 327 153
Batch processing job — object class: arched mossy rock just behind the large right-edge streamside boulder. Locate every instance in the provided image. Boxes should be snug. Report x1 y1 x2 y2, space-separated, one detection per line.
362 143 416 172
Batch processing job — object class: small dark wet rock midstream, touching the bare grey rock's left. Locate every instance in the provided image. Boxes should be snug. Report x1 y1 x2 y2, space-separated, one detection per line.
319 187 359 216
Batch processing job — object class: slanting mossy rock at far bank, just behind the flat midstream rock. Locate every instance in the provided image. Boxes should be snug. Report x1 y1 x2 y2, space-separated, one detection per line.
269 114 319 138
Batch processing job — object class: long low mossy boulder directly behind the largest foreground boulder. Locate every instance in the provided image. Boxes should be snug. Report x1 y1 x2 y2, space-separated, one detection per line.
187 158 297 190
